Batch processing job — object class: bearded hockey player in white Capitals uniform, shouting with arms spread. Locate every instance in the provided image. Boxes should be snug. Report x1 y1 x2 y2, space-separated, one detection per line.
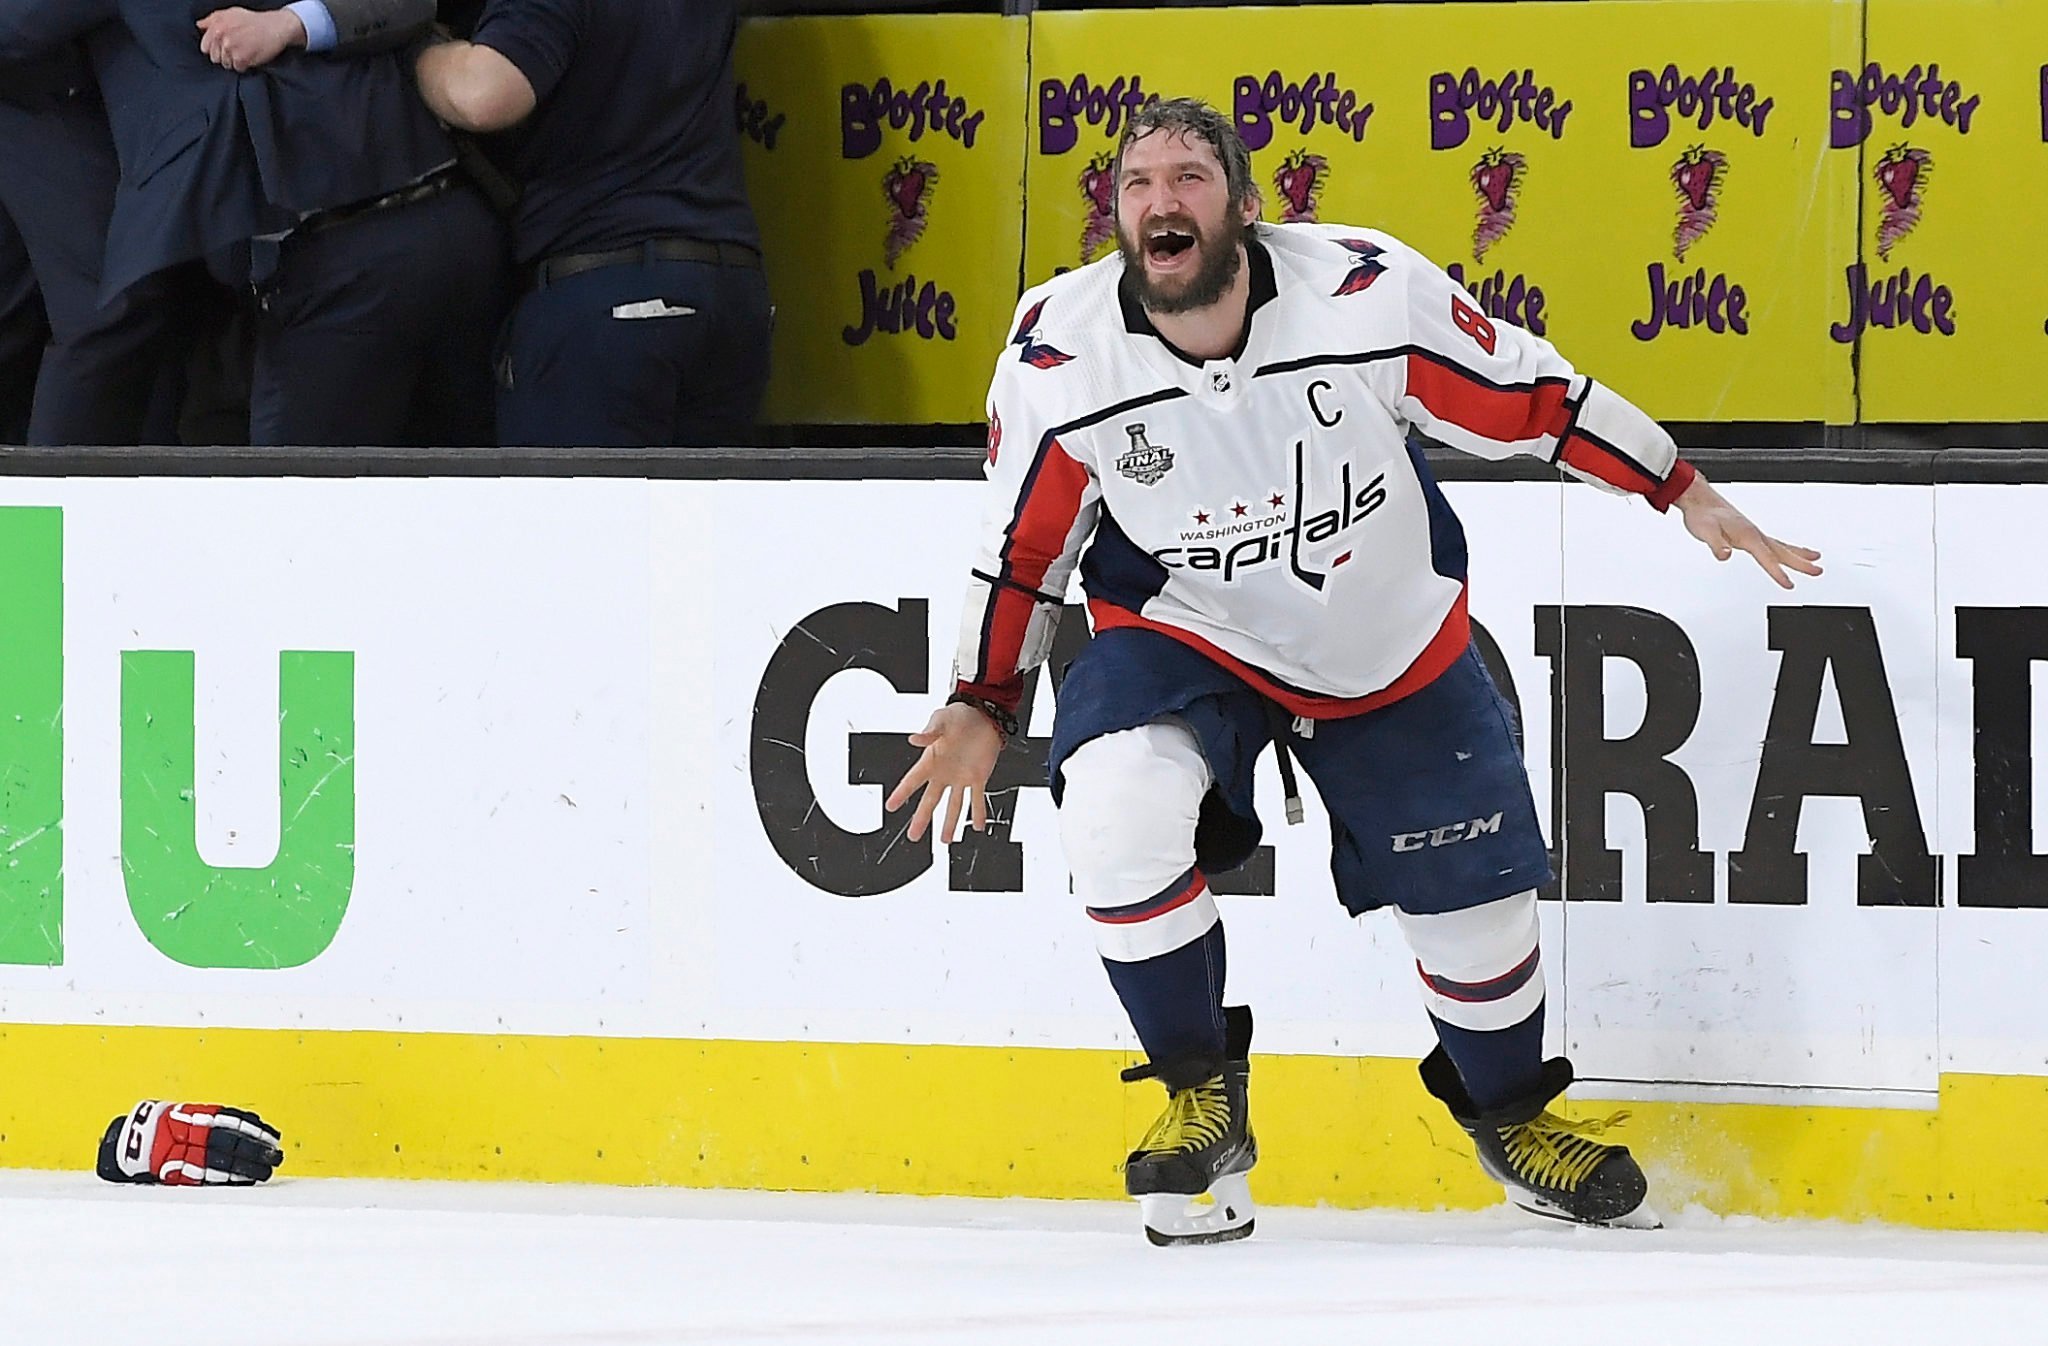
889 98 1821 1244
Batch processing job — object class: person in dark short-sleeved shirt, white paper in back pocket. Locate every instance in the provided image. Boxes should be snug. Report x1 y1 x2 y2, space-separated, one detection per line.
416 0 770 447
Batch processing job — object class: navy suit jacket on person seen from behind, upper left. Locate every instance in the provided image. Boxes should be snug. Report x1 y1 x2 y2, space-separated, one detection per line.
0 0 455 297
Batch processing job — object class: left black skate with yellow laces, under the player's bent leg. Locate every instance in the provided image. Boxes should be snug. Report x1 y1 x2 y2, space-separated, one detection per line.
1122 1006 1260 1248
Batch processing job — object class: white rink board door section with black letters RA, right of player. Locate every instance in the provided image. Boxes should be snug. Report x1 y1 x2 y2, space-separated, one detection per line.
1565 486 1937 1090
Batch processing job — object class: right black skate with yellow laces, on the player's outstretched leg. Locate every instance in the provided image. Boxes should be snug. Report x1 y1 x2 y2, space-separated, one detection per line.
1421 1047 1663 1229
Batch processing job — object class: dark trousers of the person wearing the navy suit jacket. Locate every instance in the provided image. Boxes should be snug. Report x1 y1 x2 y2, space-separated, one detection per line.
250 184 512 449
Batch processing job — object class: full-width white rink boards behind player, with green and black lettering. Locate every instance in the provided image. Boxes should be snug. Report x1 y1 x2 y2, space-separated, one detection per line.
0 479 2048 1090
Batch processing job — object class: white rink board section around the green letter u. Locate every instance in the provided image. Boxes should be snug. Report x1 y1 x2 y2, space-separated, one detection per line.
0 479 655 1033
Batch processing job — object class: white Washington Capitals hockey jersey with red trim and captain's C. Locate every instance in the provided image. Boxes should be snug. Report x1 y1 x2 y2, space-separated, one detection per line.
954 225 1694 717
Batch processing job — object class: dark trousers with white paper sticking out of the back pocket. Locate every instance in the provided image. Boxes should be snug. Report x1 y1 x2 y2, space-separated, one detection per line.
498 248 770 449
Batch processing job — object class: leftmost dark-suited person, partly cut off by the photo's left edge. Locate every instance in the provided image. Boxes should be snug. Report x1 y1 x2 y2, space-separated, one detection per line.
0 45 188 445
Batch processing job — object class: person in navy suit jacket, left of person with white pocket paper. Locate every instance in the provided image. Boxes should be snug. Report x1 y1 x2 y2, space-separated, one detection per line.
0 0 506 445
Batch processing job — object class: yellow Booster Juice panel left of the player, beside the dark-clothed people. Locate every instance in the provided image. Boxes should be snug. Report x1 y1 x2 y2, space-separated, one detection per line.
735 14 1026 424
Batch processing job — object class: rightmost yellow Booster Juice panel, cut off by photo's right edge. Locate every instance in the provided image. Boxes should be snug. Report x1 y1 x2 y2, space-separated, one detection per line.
1859 0 2048 422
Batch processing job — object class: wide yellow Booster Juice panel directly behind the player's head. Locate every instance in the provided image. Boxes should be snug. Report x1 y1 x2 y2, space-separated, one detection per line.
1024 0 1858 420
